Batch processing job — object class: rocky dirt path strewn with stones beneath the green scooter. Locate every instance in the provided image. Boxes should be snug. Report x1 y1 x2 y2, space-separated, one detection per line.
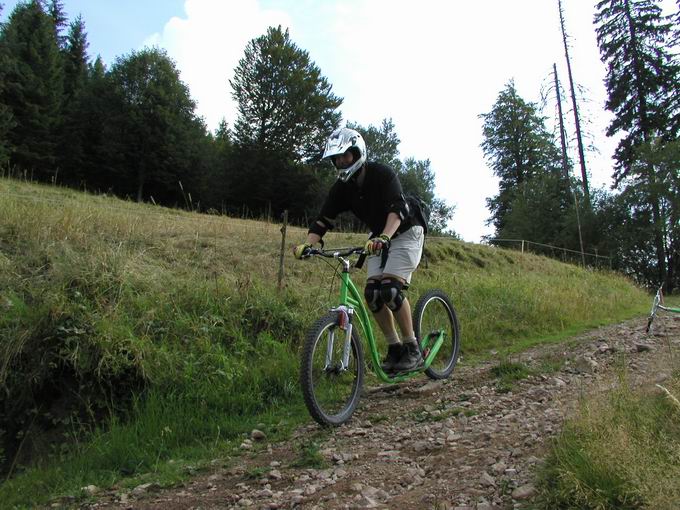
82 316 680 510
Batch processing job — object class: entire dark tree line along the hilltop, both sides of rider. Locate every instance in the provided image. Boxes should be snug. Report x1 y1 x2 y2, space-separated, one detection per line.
0 0 680 291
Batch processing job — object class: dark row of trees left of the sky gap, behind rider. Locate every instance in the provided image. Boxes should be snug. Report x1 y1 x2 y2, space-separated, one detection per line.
0 0 453 234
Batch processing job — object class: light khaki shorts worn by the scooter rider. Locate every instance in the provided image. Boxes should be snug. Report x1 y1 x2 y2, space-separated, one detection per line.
366 225 425 284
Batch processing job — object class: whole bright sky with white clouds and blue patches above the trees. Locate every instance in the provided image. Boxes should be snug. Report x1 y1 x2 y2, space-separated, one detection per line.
0 0 676 242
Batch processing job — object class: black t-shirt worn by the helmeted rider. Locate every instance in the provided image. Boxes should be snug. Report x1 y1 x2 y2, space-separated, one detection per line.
321 162 413 235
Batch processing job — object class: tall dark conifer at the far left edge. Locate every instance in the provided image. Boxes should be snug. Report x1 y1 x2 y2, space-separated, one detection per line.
0 0 63 179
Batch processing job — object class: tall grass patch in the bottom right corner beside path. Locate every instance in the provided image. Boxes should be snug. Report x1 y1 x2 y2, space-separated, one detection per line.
537 366 680 510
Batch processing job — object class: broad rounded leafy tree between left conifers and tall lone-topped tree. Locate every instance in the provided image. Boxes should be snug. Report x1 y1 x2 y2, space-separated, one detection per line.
109 48 206 203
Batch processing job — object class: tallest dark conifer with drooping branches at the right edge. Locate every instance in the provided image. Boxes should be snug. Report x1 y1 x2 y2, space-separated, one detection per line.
595 0 680 287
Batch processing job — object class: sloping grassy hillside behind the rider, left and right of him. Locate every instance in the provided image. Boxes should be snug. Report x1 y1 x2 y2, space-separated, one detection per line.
0 179 650 504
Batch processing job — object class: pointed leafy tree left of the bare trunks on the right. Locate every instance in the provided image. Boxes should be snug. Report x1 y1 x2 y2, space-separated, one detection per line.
481 81 569 240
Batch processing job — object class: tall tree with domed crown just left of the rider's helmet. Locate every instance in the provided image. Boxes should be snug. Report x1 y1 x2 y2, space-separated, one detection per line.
225 26 342 221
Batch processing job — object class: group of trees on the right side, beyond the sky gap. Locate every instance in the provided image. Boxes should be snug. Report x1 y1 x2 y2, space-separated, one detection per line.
481 0 680 292
